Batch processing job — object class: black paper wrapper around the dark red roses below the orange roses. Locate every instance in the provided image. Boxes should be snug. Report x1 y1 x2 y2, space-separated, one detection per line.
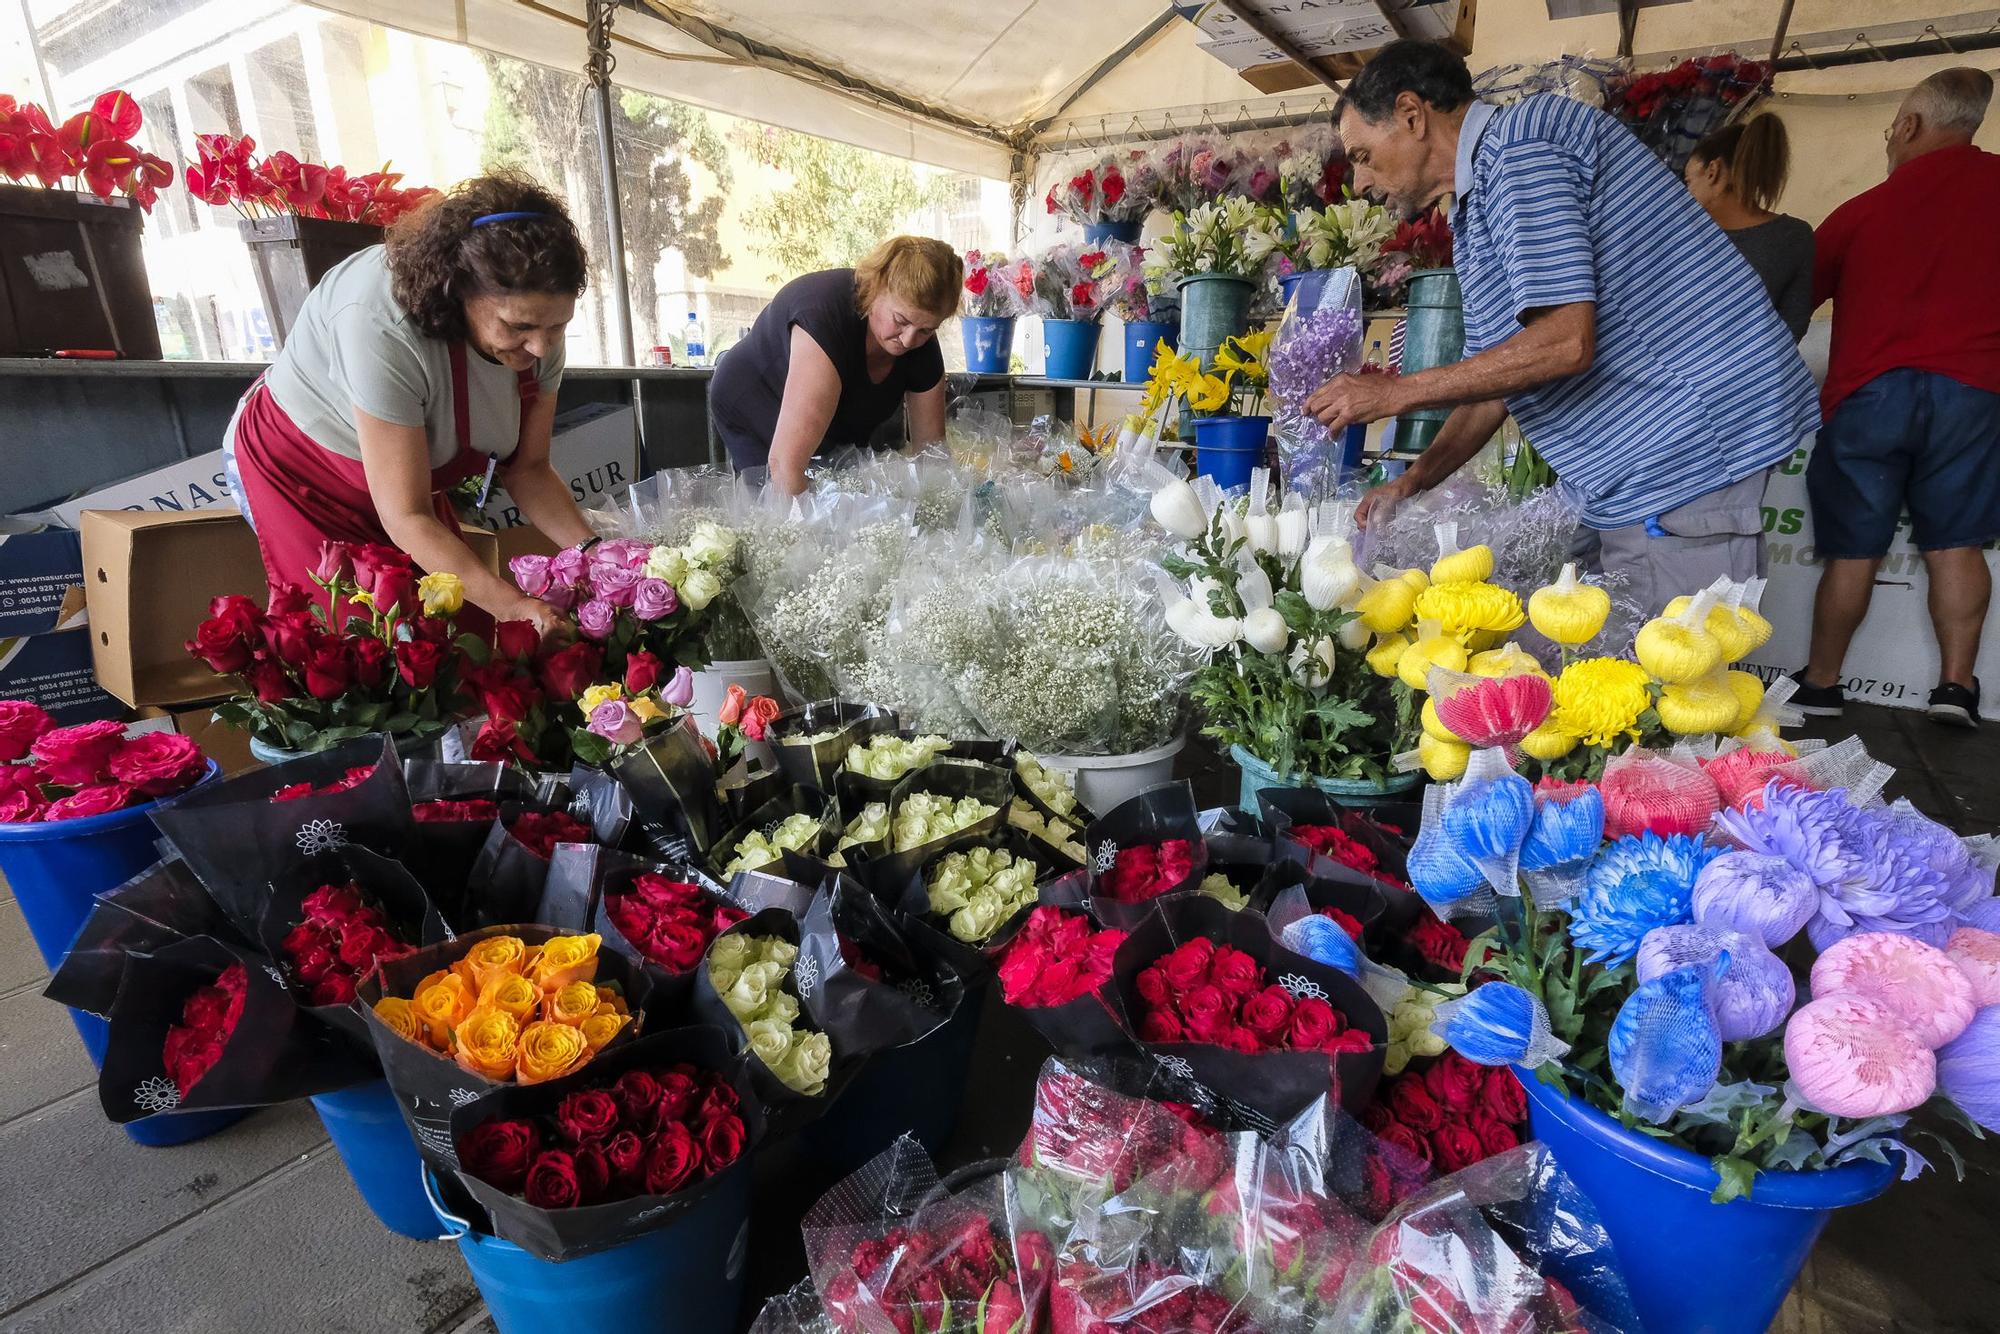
450 1026 766 1264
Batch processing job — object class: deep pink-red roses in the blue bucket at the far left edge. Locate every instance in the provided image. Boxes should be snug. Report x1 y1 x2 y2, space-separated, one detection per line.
0 700 214 824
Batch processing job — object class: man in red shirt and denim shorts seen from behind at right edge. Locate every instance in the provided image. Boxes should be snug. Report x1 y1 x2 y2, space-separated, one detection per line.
1794 68 2000 728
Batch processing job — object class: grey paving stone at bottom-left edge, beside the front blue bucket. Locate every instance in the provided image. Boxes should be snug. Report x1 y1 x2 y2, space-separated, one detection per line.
4 1148 478 1334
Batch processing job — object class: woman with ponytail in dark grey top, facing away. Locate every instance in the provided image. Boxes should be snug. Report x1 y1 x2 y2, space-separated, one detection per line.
1684 116 1812 342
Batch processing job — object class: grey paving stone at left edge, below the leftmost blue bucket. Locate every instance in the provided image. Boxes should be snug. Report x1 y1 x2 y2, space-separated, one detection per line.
0 1088 328 1330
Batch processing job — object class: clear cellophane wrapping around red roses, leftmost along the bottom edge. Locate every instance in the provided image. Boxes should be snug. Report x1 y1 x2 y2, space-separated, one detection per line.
802 1136 1050 1334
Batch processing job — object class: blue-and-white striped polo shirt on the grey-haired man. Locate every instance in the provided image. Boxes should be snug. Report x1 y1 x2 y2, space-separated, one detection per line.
1452 94 1818 528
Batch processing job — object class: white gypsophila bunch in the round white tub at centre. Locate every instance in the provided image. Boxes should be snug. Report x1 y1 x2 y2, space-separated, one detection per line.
958 556 1192 754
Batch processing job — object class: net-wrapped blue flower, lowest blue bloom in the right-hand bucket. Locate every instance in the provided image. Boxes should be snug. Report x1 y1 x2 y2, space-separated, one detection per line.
1608 954 1730 1124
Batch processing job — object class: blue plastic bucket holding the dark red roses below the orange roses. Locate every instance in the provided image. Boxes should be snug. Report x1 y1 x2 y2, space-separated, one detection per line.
424 1158 750 1334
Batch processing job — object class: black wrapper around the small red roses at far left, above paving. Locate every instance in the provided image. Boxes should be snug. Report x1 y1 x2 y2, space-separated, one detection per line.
98 936 374 1124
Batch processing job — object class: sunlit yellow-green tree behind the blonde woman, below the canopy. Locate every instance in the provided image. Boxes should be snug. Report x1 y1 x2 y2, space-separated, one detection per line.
736 124 952 282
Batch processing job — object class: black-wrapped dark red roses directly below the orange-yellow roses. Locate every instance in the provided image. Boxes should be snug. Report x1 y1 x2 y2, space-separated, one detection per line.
450 1028 764 1262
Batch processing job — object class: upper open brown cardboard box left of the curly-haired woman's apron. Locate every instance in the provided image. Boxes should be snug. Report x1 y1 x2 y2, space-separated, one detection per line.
82 510 264 706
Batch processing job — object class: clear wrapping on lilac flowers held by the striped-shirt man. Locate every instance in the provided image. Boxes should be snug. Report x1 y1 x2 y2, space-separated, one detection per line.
1268 268 1362 496
